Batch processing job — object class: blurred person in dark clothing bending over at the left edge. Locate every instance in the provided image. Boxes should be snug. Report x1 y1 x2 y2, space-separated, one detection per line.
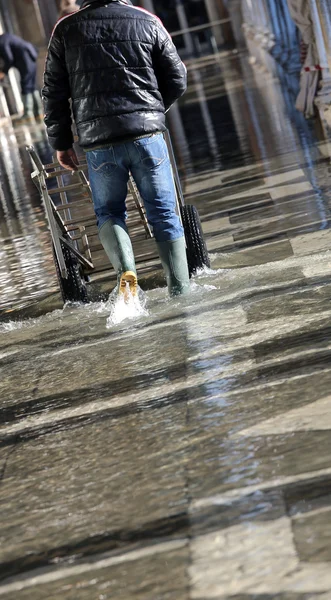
0 33 43 122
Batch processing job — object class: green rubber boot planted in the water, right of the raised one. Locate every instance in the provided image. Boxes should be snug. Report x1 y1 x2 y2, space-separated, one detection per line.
156 237 190 296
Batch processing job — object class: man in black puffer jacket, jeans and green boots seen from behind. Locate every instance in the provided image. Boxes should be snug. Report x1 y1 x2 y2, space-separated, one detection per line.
43 0 189 295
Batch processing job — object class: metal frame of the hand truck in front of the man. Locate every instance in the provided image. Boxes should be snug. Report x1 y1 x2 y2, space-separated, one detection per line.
26 130 209 296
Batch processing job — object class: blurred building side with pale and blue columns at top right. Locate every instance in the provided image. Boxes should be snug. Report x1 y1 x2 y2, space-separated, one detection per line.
243 0 331 139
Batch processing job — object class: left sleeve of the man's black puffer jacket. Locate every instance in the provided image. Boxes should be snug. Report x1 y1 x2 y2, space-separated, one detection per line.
42 27 73 150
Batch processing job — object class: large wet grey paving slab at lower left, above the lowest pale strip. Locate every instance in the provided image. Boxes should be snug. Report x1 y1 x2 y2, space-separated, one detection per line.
0 406 187 578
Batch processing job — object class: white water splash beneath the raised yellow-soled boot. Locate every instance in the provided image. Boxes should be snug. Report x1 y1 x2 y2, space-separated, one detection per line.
106 284 149 329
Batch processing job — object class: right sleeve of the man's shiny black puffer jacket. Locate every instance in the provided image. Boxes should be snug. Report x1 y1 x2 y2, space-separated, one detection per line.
153 24 187 110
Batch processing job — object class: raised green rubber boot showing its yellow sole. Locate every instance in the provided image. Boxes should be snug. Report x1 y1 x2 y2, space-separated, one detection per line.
99 219 138 296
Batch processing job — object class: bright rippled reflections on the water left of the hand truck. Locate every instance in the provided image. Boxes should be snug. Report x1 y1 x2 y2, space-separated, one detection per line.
0 122 56 310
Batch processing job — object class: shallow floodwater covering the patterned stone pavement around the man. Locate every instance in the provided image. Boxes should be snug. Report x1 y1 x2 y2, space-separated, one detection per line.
0 55 331 600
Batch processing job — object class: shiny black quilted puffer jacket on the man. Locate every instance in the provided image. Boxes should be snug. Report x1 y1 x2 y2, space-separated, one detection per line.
43 0 186 150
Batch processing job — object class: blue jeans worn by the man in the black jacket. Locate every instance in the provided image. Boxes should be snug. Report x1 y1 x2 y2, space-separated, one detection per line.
87 133 184 242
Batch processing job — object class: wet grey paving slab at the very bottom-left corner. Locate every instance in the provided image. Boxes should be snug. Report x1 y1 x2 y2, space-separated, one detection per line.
1 544 190 600
